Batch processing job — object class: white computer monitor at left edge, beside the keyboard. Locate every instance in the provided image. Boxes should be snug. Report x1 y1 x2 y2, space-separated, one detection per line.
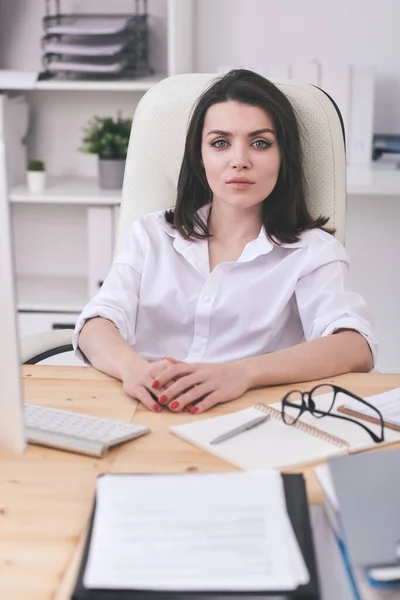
0 139 26 454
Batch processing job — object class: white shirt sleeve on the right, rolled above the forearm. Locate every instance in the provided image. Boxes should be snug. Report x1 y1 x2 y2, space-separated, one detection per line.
296 232 378 365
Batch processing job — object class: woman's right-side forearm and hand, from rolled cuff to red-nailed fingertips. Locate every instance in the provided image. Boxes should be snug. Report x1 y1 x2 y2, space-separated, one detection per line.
152 330 373 414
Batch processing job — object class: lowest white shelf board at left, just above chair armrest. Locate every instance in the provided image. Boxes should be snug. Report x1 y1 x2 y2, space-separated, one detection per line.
17 275 88 312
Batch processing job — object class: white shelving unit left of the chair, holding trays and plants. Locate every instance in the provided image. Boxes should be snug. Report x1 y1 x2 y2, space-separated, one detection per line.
0 0 193 335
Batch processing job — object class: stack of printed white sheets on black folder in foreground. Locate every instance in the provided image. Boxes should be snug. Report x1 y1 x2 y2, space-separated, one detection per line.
83 471 309 591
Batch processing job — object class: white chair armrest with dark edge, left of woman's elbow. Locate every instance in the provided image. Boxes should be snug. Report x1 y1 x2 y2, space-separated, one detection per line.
20 329 73 365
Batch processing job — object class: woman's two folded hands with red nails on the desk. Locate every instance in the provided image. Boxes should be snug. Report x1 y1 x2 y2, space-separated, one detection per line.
123 357 250 414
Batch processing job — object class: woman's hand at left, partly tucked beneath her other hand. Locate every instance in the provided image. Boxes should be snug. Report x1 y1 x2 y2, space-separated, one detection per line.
122 358 175 412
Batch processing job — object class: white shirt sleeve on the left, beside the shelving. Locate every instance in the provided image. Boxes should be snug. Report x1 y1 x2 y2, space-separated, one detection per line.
72 221 146 365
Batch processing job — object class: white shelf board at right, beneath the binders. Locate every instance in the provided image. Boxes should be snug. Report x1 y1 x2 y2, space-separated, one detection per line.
347 165 400 196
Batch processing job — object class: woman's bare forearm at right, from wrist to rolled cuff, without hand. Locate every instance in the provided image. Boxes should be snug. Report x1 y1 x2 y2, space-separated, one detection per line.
236 330 373 387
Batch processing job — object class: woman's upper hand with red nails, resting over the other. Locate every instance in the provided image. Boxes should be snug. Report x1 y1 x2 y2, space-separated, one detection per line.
152 359 250 414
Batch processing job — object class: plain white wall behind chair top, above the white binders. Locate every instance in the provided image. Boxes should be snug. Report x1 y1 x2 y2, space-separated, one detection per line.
195 0 400 133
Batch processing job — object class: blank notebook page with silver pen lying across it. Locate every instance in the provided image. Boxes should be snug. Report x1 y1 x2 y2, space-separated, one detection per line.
171 404 343 470
